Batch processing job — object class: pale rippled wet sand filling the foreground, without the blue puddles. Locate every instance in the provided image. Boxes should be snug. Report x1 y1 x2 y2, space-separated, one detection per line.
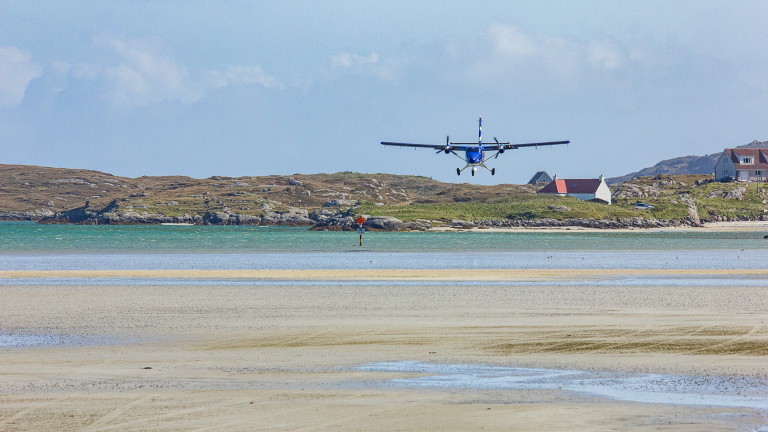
0 270 768 431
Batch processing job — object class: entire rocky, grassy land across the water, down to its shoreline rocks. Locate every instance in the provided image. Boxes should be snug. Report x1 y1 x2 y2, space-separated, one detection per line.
0 165 768 230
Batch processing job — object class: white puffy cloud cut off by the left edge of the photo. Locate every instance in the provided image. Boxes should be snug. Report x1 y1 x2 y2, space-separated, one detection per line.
0 47 43 106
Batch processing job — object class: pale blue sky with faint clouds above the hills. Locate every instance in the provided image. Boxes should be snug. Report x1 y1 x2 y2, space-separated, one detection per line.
0 0 768 184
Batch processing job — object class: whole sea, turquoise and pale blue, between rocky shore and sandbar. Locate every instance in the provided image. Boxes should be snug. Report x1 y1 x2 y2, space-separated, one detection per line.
0 222 768 272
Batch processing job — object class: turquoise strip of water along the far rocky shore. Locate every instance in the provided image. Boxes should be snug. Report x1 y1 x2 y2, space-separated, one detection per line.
0 222 768 255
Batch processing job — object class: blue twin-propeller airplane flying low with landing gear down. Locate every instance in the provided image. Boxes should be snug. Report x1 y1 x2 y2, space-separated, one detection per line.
381 116 570 176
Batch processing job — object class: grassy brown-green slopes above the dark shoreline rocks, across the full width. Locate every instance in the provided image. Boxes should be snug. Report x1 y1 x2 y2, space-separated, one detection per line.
0 165 768 223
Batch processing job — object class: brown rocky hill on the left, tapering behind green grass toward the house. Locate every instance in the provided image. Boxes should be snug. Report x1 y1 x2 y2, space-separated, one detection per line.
0 164 535 226
